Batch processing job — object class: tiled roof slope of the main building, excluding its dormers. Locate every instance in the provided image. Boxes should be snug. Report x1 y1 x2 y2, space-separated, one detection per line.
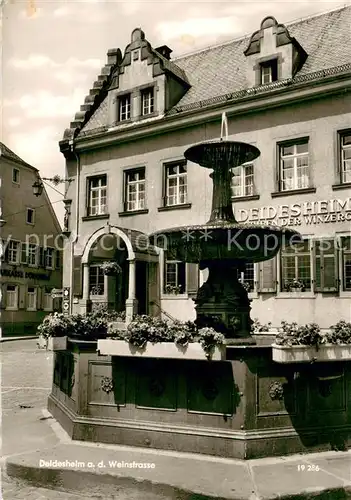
65 6 351 143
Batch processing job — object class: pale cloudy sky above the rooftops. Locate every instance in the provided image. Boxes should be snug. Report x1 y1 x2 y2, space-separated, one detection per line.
0 0 351 223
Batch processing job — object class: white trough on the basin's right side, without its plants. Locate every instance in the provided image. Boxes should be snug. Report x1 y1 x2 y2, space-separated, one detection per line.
272 344 351 363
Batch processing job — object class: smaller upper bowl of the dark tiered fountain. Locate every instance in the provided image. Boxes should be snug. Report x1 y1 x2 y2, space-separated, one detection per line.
184 140 261 170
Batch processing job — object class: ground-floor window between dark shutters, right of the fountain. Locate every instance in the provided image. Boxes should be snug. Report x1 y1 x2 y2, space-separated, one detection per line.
281 240 311 292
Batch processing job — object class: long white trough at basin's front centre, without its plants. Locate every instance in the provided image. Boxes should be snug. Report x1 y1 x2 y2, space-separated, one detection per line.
97 339 225 361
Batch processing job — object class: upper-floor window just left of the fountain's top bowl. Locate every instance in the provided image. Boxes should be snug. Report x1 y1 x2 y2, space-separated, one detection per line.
165 162 187 206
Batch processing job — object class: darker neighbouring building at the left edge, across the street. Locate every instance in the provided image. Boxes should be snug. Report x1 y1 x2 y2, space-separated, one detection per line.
0 143 62 335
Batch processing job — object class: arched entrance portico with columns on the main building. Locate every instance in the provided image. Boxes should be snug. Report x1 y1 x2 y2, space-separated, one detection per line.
80 225 158 322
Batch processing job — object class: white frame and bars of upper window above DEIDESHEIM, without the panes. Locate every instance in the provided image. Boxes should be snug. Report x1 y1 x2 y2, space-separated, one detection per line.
278 138 311 192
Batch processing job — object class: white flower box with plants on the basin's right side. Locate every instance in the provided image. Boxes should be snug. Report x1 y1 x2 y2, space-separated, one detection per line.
272 321 351 363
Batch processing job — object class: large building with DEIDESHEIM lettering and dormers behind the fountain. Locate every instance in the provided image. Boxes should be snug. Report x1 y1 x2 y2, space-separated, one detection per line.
60 6 351 328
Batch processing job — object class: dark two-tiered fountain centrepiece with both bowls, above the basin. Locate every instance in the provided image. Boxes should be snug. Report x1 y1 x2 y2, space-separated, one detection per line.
152 113 300 343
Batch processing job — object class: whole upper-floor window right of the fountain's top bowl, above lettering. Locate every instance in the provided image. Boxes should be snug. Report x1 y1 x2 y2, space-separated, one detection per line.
279 139 310 191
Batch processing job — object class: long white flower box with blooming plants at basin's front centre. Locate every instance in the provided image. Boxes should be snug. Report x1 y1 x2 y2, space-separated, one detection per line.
98 315 224 360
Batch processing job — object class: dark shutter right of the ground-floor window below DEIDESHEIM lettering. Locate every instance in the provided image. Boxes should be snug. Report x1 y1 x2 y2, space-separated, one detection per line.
314 239 338 292
